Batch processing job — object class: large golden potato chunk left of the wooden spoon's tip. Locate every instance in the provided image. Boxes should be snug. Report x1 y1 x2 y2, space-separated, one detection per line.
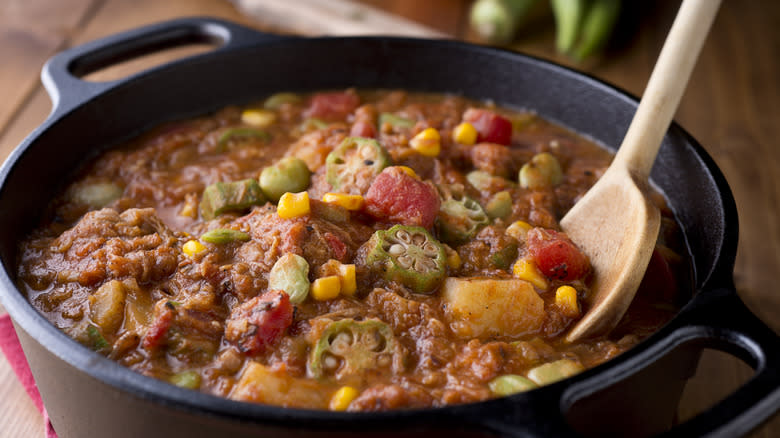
442 277 545 338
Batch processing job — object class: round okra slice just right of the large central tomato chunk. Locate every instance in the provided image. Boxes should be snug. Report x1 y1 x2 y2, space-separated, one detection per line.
436 196 490 243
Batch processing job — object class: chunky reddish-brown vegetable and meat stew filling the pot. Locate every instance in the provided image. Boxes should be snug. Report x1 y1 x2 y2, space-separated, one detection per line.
18 90 686 411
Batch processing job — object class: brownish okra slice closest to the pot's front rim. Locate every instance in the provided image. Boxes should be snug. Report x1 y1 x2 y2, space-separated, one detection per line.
308 319 400 381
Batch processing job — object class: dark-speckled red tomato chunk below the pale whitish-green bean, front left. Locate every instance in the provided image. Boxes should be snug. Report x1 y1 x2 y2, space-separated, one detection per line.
225 290 293 356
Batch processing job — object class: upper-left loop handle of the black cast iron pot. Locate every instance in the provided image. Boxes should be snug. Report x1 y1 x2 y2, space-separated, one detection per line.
41 17 290 116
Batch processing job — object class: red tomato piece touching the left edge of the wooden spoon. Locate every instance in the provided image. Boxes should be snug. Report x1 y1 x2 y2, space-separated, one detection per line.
526 228 590 281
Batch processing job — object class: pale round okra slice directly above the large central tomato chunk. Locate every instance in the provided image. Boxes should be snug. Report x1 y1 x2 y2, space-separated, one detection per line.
325 137 390 195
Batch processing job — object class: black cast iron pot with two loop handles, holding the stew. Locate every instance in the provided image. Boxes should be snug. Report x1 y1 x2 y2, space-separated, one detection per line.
0 18 780 438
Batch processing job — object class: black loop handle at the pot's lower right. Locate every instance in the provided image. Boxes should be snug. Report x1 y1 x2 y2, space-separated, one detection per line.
661 287 780 437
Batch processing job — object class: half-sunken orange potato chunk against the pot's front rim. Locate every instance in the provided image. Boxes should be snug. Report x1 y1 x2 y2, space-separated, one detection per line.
230 362 329 409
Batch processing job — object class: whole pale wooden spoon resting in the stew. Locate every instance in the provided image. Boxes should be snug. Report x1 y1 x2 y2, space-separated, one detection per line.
561 0 721 342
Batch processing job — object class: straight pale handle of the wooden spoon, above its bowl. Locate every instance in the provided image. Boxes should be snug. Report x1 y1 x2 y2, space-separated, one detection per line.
614 0 721 181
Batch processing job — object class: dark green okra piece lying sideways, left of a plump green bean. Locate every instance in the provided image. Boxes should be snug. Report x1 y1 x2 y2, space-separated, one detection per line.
200 179 265 220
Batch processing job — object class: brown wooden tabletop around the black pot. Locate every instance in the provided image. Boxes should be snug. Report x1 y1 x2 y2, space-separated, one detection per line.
0 0 780 437
